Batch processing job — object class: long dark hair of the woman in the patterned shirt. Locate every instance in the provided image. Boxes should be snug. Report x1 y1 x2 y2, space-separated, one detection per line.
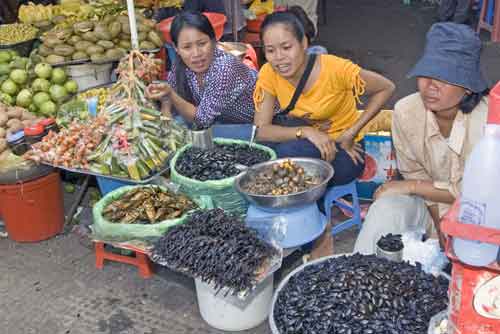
170 11 216 103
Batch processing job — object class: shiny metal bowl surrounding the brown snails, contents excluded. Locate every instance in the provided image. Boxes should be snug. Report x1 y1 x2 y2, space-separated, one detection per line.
234 158 333 209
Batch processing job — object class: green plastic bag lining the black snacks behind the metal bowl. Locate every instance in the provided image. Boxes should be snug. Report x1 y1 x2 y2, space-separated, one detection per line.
170 138 276 215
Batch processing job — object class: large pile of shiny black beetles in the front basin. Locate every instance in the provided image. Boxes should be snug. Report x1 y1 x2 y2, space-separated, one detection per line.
272 254 448 334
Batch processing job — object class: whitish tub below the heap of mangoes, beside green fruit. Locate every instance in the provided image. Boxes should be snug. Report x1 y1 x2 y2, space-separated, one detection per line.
67 63 113 92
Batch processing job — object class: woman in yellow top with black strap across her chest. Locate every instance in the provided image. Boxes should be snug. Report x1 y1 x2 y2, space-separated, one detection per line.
254 12 394 185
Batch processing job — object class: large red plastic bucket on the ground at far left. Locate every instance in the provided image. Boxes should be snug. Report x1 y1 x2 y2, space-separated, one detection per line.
0 173 64 242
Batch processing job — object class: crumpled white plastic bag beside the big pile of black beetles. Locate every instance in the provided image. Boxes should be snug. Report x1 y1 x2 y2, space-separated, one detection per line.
402 232 448 276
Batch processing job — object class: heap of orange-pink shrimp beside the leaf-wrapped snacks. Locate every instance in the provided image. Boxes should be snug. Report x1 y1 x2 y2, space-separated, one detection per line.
25 116 108 169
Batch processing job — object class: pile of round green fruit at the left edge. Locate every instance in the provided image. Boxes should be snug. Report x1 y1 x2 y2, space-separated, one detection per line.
0 50 78 117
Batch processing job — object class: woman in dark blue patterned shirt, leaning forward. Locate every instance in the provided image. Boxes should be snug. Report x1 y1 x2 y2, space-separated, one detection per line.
147 12 257 128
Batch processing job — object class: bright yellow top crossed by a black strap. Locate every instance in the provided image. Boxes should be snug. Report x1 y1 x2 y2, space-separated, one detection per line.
254 55 365 141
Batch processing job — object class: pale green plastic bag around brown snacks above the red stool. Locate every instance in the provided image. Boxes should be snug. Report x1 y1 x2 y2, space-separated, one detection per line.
91 185 208 243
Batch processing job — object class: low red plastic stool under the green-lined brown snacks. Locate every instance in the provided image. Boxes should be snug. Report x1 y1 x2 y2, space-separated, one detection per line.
94 241 153 278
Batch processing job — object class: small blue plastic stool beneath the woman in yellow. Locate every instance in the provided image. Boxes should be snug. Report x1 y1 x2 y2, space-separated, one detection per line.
323 180 361 235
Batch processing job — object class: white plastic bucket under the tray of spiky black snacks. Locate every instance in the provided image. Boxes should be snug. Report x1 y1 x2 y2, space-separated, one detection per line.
195 276 273 331
